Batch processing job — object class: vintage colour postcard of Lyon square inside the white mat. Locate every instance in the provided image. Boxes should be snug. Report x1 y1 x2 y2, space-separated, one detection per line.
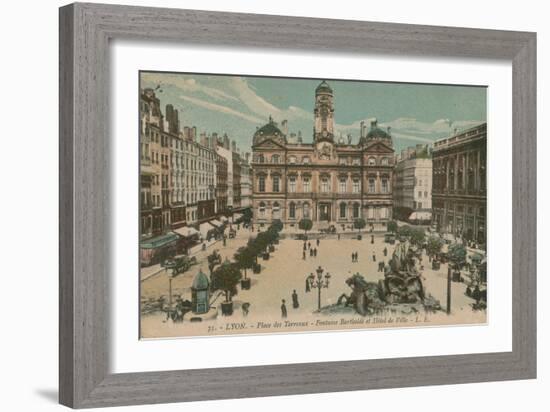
137 71 490 338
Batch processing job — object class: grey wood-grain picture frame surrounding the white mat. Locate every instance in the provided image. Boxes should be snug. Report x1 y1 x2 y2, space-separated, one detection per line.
59 3 536 408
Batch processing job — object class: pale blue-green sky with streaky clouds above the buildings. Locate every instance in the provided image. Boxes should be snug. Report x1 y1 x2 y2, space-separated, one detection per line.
140 72 487 151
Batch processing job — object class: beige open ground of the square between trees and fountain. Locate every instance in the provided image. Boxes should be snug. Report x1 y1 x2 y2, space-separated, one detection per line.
141 230 485 336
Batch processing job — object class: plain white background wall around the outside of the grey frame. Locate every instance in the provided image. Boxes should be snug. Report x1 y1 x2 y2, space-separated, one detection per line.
0 0 550 412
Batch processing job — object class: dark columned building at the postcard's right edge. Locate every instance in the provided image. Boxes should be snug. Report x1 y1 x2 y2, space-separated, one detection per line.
432 123 487 244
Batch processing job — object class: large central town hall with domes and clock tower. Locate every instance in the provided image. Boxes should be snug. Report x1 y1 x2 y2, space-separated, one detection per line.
252 82 394 226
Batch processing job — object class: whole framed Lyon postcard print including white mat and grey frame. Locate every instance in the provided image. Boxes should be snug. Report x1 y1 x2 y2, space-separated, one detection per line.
60 3 536 408
